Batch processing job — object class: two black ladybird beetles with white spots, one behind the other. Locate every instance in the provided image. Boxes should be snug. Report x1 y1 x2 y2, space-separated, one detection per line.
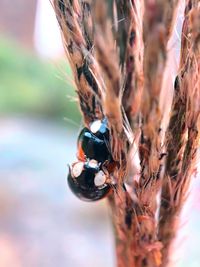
68 119 115 201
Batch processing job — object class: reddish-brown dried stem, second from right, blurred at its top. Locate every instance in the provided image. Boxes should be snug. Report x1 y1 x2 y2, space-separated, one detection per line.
139 0 180 212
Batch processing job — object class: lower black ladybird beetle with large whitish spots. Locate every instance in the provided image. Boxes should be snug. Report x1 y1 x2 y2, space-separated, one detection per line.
68 160 111 201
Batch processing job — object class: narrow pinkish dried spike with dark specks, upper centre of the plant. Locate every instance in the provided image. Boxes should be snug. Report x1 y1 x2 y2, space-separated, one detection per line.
122 0 144 126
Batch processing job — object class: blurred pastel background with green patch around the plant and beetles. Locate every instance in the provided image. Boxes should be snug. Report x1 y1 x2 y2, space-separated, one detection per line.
0 0 200 267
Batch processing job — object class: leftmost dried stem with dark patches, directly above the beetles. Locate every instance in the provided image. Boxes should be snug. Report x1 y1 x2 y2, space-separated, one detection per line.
54 0 103 125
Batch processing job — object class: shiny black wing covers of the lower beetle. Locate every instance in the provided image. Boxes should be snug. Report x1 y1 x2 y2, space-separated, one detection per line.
67 163 111 201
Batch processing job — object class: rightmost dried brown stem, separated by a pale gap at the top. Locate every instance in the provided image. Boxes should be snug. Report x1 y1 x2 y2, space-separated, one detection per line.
159 1 200 266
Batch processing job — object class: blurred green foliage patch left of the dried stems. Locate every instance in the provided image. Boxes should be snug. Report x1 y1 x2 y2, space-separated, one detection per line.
0 39 80 126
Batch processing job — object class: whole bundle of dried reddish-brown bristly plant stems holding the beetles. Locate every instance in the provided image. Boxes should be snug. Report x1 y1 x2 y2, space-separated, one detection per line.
52 0 200 267
